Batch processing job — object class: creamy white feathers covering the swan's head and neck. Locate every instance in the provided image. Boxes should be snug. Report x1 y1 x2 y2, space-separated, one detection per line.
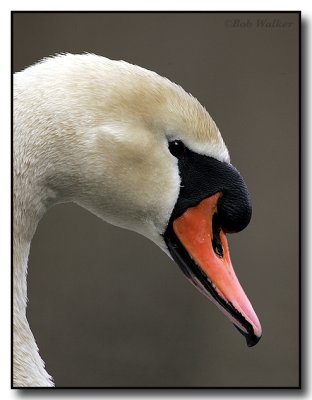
13 54 229 386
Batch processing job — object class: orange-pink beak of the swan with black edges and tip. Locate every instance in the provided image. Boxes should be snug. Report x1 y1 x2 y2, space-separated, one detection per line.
167 193 262 346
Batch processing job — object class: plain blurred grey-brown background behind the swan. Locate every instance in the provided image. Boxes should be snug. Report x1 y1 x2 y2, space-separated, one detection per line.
13 13 299 387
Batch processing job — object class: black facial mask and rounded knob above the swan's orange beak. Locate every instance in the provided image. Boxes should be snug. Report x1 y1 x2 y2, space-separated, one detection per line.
169 140 252 233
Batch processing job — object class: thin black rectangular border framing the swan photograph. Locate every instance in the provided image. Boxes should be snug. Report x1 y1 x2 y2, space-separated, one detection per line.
10 9 302 390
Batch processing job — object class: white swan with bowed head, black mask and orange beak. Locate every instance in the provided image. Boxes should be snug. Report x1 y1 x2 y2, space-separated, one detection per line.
13 54 261 387
